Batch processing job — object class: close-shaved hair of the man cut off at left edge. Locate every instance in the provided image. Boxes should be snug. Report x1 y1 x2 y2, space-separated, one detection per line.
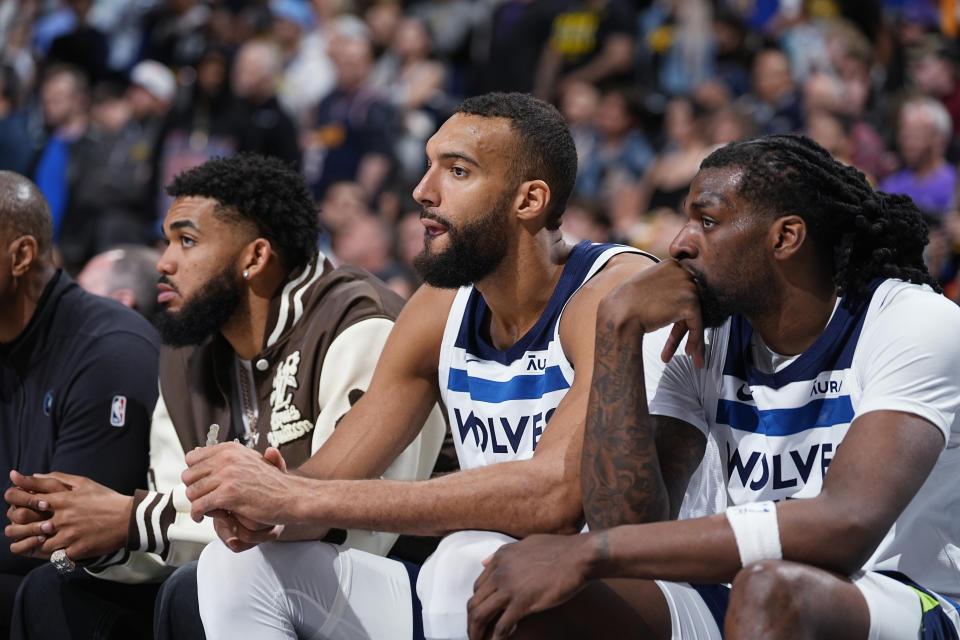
0 171 53 255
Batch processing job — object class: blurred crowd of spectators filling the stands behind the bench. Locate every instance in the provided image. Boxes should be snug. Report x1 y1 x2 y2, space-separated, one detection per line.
0 0 960 300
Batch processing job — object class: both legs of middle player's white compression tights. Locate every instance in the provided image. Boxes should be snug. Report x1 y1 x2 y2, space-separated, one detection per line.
197 531 515 640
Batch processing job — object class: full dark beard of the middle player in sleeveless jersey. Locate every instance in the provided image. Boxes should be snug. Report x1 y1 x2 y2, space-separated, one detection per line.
413 194 512 289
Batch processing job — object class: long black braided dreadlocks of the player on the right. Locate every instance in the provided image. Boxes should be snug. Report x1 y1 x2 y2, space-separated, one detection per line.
700 135 941 298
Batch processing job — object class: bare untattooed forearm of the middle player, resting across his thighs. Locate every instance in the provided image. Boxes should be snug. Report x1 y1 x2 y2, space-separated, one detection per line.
283 461 582 537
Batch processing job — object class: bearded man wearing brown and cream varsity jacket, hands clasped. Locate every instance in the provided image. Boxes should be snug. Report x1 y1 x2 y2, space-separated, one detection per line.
8 155 445 637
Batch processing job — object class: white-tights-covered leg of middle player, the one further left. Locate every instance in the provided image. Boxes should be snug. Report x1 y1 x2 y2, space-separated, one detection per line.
197 540 413 640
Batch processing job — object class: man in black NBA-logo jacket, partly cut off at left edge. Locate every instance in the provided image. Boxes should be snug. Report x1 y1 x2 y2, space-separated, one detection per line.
0 171 159 637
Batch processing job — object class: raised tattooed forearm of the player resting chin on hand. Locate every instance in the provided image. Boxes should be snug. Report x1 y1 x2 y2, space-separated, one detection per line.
580 321 670 529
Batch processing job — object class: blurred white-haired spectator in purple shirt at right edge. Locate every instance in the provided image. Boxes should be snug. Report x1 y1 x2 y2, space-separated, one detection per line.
877 96 957 218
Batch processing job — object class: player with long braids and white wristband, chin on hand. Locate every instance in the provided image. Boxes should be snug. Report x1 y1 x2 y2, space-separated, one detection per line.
470 136 960 640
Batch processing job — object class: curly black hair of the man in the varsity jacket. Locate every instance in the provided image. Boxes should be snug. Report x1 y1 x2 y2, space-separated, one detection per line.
167 153 320 272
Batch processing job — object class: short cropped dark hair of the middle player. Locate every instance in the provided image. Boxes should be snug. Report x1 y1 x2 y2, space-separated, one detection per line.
456 92 577 230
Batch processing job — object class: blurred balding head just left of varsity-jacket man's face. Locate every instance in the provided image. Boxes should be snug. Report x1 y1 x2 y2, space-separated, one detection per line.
77 245 160 320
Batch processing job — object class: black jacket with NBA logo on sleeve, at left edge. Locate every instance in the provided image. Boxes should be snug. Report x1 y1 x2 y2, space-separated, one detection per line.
0 271 159 574
